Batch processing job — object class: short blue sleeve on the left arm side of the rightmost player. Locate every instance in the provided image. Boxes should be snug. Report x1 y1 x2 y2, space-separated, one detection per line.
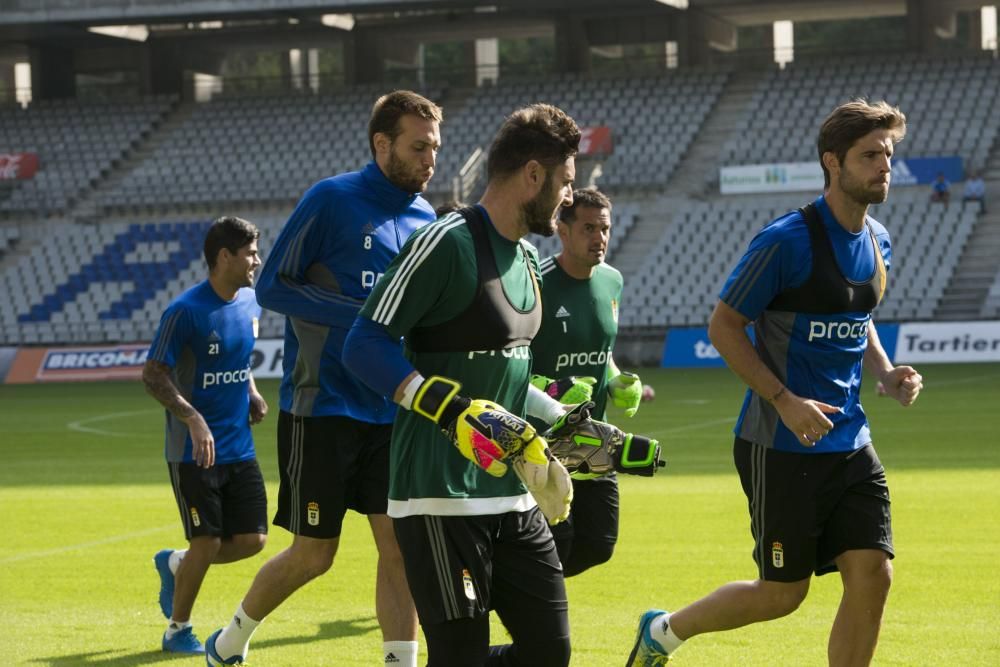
719 213 812 320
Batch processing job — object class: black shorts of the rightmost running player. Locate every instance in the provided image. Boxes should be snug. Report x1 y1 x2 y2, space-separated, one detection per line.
733 438 894 582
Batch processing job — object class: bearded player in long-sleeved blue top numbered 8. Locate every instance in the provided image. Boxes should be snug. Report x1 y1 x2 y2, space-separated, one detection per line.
206 91 441 667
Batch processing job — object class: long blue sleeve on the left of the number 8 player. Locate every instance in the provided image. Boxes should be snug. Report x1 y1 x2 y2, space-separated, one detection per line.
257 186 364 326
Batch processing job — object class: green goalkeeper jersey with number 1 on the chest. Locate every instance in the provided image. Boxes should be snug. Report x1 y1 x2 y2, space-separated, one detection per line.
531 257 622 419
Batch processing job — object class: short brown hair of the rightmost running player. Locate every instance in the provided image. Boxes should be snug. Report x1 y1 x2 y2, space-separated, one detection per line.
816 98 906 186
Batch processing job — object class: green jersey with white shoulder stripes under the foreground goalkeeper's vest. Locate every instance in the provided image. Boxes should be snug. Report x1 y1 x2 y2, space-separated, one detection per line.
361 209 538 517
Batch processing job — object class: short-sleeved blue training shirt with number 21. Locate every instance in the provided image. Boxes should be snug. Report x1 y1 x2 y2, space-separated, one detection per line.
148 280 261 463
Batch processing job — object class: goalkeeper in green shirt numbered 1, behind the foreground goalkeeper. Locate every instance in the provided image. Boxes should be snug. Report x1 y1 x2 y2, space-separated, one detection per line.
531 188 642 577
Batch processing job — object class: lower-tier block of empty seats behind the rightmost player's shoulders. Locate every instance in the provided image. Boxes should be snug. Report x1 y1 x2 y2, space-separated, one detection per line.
621 188 978 327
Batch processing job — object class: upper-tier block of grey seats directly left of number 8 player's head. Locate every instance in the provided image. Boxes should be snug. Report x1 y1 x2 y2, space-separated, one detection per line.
99 87 440 214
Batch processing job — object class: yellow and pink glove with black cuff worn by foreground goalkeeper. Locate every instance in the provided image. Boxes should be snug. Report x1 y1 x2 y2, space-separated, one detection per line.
412 375 540 477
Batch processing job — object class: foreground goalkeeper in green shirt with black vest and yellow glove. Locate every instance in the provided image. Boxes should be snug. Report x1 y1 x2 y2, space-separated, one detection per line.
343 104 580 667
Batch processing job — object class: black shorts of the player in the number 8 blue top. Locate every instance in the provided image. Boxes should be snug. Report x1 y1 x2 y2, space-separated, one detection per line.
274 411 392 539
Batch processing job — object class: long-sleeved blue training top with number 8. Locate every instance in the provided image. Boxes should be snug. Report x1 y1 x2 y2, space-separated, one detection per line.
257 162 435 424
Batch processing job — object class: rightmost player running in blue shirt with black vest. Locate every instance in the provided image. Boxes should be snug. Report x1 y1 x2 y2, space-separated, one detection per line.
628 100 922 666
